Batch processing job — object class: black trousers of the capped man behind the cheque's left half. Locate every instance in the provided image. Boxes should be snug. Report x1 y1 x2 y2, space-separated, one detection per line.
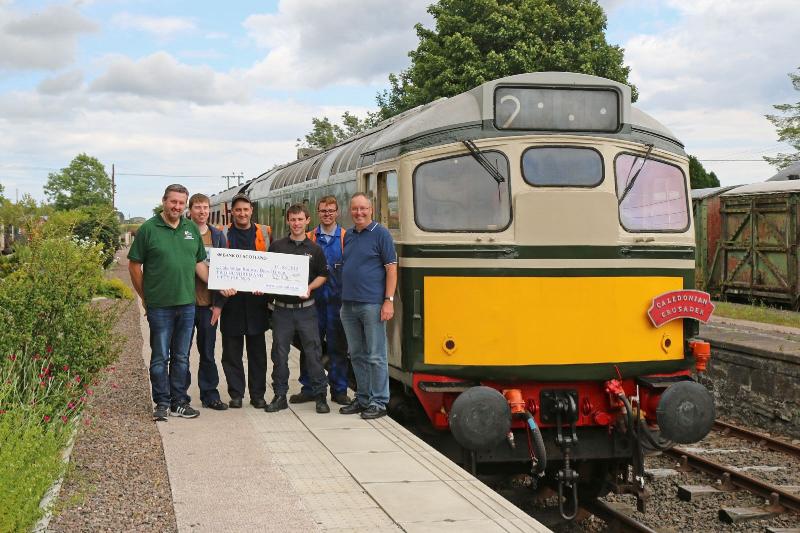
222 333 267 400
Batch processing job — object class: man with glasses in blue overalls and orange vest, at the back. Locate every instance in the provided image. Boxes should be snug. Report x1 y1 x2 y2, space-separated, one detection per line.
289 196 350 405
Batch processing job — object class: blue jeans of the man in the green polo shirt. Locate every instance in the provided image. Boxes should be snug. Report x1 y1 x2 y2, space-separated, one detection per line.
147 303 194 407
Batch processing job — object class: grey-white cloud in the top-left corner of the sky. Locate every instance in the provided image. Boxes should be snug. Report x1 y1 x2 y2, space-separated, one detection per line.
0 4 99 70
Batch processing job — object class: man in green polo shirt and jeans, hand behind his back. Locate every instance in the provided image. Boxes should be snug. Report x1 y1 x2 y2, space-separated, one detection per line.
128 184 208 421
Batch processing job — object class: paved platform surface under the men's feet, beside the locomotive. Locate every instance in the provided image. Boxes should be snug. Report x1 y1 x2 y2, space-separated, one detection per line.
140 302 550 533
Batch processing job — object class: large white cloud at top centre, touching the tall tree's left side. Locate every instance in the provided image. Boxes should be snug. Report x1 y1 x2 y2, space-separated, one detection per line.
244 0 432 90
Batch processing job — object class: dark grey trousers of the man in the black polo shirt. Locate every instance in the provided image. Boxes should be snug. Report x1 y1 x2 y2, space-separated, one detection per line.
272 305 328 397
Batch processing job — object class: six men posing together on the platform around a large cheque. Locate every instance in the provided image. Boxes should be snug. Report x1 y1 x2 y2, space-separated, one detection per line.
128 184 397 421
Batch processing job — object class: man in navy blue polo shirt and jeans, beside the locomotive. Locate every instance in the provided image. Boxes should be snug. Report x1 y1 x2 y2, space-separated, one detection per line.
339 193 397 419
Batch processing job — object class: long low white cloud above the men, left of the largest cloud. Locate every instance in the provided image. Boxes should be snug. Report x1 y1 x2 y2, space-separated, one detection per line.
90 52 247 105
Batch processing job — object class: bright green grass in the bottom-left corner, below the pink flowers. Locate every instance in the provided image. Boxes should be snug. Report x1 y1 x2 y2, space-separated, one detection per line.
0 411 69 531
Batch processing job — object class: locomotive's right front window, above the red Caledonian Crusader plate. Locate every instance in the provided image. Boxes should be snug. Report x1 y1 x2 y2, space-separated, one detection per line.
614 154 689 232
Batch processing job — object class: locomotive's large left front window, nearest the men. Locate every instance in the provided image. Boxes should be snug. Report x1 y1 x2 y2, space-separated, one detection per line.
414 152 511 231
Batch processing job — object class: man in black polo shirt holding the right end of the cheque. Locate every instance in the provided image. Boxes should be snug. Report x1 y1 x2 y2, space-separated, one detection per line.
265 204 331 413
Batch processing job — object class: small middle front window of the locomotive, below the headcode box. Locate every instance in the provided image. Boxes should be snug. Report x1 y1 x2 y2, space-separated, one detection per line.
522 147 603 187
